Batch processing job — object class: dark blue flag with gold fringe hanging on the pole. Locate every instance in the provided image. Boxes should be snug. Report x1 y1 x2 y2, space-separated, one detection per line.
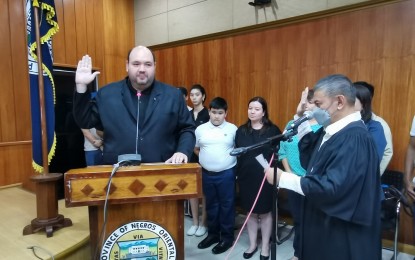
26 0 59 173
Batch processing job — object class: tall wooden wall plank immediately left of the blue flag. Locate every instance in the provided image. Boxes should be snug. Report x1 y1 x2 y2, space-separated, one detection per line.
10 1 32 141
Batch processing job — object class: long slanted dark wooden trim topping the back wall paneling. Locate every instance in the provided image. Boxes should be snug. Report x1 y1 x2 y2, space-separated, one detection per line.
149 0 409 51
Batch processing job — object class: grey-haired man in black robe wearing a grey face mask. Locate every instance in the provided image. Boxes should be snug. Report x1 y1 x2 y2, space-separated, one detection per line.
267 75 381 260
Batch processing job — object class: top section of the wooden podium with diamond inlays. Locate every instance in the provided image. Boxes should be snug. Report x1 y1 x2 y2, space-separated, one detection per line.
65 164 202 207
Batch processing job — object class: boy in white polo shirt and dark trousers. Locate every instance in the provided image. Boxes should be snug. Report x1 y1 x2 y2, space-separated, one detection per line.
195 97 237 254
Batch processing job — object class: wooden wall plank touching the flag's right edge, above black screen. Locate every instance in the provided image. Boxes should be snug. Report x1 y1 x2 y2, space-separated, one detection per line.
52 0 67 64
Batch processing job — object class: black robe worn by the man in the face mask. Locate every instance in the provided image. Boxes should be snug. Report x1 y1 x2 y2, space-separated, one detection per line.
299 120 381 260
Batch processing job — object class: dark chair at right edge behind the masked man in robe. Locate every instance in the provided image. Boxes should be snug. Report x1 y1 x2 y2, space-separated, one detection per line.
381 170 407 260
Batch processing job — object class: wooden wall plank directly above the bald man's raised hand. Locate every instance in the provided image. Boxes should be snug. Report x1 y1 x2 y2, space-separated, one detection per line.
73 0 91 59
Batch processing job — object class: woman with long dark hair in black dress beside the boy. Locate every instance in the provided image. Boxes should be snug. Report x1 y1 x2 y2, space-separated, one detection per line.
235 97 281 259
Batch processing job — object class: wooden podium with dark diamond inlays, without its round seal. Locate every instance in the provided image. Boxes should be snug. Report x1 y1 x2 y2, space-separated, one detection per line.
65 163 202 259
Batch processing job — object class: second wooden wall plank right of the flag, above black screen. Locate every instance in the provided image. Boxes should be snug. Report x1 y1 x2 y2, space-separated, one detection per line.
63 0 78 65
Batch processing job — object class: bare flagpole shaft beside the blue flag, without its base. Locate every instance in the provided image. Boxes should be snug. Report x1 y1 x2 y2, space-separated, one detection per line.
33 3 49 174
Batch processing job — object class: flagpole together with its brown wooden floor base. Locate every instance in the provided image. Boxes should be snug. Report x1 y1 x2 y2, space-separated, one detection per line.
23 0 72 237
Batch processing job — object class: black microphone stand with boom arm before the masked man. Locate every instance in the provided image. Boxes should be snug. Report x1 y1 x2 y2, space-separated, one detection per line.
231 129 298 260
